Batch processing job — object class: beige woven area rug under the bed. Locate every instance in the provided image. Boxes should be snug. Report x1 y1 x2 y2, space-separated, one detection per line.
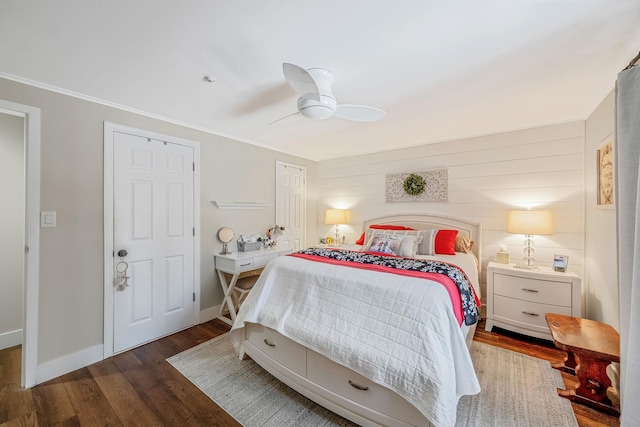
167 334 578 427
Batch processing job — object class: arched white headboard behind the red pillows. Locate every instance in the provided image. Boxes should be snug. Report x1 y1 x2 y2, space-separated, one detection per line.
362 213 482 261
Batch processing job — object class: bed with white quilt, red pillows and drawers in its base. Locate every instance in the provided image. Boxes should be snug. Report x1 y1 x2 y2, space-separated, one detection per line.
230 214 482 427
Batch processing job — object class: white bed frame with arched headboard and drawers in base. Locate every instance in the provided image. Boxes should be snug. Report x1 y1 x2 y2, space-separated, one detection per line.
240 214 482 427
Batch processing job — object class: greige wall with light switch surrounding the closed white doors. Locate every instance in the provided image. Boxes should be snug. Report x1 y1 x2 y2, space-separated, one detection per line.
0 79 317 372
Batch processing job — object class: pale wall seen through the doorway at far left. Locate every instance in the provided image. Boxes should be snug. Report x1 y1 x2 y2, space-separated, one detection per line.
0 112 25 349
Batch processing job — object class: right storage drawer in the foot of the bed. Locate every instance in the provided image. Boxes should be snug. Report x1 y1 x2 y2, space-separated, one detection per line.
307 349 424 425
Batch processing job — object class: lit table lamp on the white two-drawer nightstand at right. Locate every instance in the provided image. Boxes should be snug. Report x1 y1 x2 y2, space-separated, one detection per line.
507 210 553 269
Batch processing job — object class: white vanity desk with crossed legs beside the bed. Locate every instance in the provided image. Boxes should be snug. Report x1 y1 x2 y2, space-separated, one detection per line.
214 246 293 325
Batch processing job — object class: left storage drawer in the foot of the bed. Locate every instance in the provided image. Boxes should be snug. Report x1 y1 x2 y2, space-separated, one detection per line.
245 323 307 376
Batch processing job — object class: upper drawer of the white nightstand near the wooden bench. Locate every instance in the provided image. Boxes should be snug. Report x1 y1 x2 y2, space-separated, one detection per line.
493 274 572 306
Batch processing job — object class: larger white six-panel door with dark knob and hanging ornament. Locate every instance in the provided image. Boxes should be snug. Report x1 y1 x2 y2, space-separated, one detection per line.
113 132 195 353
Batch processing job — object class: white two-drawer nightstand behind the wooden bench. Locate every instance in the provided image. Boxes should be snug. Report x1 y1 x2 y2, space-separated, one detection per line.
485 262 582 340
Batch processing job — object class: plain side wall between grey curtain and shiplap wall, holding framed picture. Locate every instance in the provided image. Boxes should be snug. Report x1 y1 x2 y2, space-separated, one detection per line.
583 91 620 329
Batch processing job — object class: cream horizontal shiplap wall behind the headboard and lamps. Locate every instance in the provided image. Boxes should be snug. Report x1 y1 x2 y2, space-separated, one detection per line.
318 121 585 295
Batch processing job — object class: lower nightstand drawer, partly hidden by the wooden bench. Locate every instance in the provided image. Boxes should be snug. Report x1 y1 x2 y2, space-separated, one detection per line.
493 295 571 334
